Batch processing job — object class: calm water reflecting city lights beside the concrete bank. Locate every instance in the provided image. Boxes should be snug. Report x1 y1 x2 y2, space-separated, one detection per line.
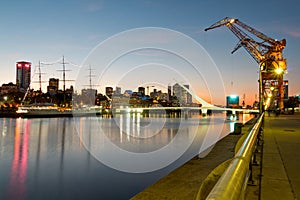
0 114 251 199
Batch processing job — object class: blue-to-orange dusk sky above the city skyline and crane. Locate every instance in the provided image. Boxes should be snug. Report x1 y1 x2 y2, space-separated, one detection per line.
0 0 300 105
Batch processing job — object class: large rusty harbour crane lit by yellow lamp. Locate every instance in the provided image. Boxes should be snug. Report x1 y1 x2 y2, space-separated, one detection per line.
205 17 286 111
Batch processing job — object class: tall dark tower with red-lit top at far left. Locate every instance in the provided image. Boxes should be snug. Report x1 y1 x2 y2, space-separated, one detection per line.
16 61 31 90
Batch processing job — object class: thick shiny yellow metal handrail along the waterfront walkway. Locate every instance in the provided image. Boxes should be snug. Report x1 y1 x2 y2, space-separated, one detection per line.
206 113 264 200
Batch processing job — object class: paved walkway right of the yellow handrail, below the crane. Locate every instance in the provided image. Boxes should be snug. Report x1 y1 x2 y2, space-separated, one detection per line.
261 113 300 200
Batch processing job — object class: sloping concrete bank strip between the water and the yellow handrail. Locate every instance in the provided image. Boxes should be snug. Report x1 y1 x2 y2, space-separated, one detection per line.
131 116 253 200
